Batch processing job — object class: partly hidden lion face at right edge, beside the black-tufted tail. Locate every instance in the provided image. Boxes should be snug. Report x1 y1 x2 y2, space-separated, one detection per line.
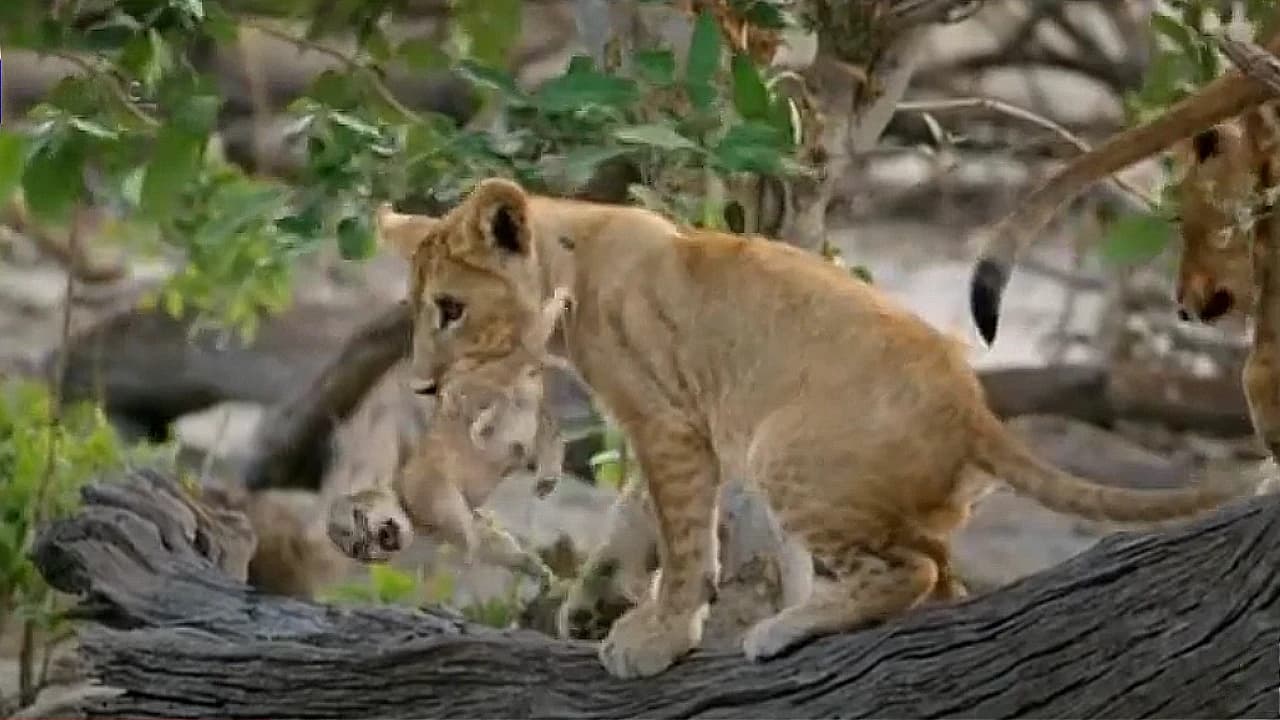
1174 122 1254 323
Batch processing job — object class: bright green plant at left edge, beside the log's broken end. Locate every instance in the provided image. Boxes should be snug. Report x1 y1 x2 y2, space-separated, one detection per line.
0 382 165 705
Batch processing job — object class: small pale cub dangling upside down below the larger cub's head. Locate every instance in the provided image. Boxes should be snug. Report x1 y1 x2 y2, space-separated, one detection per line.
328 291 567 583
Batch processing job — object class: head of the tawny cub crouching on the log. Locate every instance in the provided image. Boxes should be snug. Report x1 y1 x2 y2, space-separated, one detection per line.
378 174 554 396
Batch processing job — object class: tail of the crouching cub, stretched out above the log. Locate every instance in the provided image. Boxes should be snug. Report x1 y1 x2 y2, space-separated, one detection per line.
973 415 1252 523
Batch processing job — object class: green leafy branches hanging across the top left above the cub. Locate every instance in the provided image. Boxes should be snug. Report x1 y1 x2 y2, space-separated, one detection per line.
0 0 803 336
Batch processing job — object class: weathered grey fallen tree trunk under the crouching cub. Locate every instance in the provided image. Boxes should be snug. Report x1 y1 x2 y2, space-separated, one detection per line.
33 471 1280 717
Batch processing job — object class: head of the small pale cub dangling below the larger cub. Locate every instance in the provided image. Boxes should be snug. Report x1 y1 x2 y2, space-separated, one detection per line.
328 491 413 562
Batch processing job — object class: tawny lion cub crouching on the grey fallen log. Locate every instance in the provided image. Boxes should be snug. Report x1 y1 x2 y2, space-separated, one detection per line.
381 179 1249 678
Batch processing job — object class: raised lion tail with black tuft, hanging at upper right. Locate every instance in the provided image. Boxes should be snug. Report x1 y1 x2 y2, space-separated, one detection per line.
969 23 1280 343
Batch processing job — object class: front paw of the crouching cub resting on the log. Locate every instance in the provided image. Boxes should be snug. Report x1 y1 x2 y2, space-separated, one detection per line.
599 602 705 679
